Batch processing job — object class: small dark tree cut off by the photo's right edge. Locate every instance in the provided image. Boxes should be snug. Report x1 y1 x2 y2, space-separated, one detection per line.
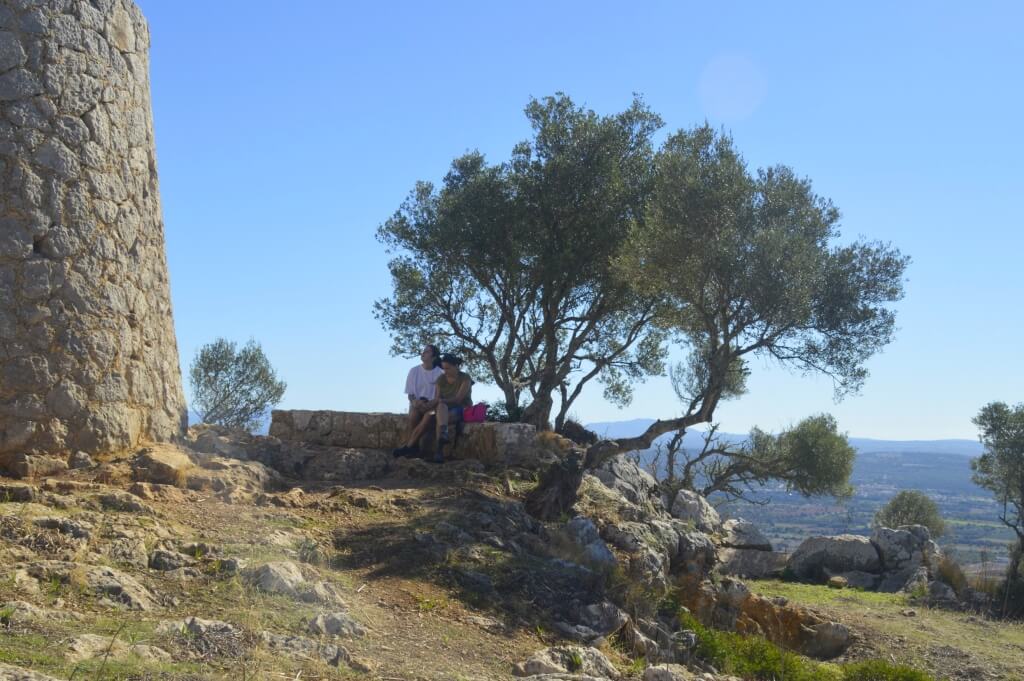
971 402 1024 589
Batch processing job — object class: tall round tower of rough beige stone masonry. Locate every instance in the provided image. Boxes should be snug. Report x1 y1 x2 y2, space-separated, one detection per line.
0 0 185 458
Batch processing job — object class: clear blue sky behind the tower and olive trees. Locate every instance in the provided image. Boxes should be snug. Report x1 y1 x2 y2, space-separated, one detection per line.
137 0 1024 439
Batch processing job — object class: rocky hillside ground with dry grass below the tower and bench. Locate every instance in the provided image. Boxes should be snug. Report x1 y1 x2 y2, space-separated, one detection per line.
0 428 1013 681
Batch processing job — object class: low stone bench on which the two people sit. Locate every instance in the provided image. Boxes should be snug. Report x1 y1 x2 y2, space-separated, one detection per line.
270 410 554 468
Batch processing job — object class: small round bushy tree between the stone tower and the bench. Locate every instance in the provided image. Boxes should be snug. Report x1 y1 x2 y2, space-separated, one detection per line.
188 338 287 431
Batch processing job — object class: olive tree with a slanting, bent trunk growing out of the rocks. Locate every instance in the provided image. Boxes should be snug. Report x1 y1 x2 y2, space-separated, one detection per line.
527 126 907 517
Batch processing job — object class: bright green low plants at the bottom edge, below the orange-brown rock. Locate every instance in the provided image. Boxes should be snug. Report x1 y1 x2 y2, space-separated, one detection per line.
680 611 934 681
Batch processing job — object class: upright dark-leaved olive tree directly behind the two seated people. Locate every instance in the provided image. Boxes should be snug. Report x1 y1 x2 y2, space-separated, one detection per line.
375 94 666 428
